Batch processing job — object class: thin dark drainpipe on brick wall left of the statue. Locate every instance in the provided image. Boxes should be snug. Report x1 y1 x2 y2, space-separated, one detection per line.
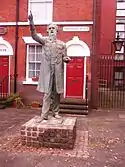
14 0 19 93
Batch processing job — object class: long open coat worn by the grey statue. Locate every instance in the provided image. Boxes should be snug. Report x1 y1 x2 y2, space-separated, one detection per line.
32 34 67 93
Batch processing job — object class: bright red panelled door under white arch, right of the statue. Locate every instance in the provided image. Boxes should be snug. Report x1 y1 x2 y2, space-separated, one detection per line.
66 57 84 99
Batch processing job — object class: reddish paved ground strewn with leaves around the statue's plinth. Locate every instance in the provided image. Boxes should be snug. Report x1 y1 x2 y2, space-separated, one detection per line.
0 108 125 167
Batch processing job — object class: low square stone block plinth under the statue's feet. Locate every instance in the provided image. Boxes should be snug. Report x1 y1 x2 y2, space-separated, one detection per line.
21 116 76 149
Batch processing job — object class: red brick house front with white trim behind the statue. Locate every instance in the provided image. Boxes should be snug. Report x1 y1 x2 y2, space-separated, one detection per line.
0 0 116 109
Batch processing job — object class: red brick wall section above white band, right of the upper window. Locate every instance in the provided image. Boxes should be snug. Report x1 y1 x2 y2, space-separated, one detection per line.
53 0 93 21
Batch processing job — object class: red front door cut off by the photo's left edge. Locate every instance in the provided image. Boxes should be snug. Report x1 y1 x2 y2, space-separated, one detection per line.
0 56 9 94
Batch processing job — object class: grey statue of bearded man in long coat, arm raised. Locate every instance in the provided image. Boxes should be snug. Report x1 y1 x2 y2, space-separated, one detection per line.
28 13 71 122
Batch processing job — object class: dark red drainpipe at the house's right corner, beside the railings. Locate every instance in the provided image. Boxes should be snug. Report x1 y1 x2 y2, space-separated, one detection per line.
91 0 101 109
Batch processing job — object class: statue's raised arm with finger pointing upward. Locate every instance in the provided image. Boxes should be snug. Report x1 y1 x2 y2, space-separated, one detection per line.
28 11 45 45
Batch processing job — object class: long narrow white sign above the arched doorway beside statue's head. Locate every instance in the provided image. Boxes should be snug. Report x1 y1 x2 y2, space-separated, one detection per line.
63 26 90 31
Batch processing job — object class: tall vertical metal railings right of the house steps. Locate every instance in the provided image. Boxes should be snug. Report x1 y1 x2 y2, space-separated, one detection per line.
98 55 125 109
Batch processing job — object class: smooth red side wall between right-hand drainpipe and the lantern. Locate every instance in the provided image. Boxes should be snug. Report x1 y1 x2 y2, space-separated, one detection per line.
100 0 116 55
